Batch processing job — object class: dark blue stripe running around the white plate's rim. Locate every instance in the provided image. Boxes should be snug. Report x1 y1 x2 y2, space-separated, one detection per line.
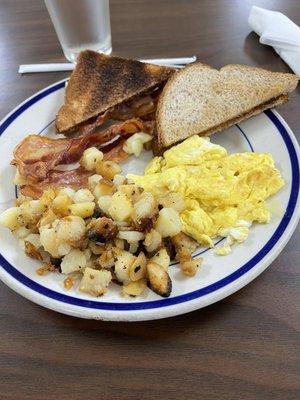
0 81 299 311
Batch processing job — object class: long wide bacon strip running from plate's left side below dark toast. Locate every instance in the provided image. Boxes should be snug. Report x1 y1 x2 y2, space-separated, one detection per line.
12 119 144 181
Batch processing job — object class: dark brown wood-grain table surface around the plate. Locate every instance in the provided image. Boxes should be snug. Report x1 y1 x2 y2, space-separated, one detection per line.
0 0 300 400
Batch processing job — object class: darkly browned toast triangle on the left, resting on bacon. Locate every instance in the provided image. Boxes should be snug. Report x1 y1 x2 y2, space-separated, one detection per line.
56 50 175 133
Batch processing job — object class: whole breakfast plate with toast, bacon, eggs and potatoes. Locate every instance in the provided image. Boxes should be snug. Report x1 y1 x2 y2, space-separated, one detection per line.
0 50 300 321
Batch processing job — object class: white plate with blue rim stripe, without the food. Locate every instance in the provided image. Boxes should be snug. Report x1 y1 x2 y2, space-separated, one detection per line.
0 81 300 321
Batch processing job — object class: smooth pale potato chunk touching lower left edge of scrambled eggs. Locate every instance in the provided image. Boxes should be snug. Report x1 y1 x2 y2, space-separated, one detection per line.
155 208 182 237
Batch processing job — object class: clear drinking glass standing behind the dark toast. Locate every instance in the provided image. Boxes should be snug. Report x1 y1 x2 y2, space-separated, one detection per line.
45 0 112 62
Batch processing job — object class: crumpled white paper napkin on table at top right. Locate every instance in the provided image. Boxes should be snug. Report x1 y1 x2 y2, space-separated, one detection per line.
248 6 300 74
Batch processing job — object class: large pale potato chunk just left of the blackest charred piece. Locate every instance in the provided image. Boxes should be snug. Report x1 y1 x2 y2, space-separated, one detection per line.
53 215 86 245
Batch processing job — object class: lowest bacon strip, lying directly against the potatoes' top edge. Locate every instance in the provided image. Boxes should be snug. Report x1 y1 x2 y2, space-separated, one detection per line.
21 167 93 199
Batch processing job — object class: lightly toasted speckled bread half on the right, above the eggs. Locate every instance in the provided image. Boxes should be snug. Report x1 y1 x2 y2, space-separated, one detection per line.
156 63 299 148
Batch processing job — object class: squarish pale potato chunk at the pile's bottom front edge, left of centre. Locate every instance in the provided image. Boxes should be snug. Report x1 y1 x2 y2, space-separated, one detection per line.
79 267 112 297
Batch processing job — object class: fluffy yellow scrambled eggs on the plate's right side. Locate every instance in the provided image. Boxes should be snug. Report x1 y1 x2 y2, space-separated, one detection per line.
128 135 284 255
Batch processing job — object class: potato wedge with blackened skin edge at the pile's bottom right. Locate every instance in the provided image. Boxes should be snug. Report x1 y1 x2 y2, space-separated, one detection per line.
147 261 172 297
